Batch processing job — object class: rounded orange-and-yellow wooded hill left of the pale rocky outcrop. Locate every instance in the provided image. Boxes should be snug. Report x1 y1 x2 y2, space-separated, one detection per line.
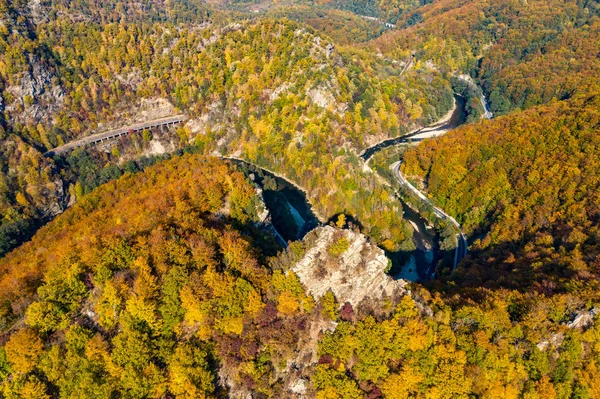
0 156 314 398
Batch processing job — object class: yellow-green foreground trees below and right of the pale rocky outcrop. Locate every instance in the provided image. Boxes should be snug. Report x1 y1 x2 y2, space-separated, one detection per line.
312 291 600 399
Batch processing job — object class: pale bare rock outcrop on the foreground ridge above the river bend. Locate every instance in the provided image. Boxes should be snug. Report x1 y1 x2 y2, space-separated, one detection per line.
292 226 408 306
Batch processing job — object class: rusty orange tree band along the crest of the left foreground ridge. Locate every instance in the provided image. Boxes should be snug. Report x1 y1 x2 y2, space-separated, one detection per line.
0 156 258 322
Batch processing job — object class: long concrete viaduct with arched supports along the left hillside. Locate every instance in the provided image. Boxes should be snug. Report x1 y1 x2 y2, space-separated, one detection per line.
44 114 186 156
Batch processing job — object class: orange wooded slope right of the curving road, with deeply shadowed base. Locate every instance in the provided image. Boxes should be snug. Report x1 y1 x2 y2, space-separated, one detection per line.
403 94 600 297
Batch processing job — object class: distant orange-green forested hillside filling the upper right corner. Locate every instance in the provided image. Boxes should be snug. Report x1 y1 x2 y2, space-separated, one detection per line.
376 0 600 114
